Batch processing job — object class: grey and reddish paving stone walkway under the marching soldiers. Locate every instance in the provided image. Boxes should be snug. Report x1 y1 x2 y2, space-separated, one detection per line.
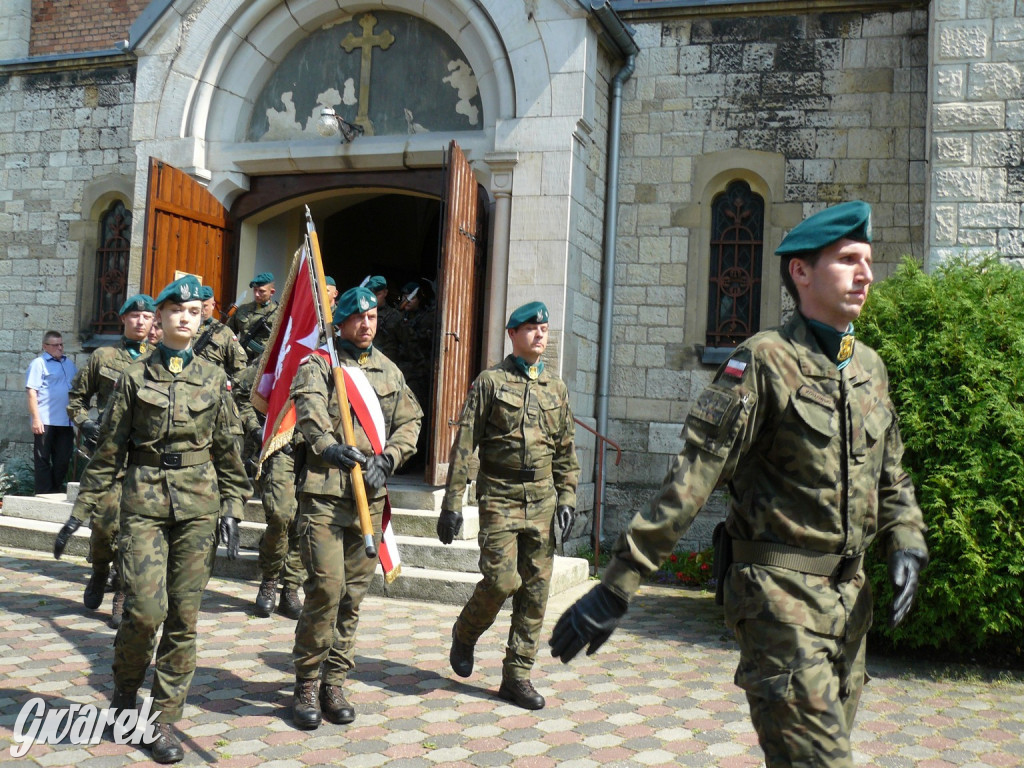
0 550 1024 768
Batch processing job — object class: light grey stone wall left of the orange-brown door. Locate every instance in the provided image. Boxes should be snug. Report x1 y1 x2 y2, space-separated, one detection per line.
0 60 135 454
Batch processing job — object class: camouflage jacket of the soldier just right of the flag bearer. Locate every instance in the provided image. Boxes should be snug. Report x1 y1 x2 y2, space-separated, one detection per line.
443 355 580 511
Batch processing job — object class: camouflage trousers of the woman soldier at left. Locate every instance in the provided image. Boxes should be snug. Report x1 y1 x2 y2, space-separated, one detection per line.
114 510 218 723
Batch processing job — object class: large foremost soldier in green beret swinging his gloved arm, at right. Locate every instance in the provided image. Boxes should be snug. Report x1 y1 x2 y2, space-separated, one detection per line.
551 201 928 768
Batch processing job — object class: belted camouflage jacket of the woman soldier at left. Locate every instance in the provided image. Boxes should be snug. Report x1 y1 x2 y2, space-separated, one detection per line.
74 354 252 520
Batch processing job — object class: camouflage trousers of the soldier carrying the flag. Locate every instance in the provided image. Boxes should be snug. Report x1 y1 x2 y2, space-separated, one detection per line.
292 494 384 685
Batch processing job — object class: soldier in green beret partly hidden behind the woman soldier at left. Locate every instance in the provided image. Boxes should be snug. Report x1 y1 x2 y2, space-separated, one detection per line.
53 294 157 629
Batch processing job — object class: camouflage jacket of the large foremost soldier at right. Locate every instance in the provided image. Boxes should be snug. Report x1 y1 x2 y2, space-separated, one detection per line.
603 312 927 636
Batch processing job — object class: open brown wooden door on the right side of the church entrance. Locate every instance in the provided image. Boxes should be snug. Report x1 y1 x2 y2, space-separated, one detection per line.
426 141 485 485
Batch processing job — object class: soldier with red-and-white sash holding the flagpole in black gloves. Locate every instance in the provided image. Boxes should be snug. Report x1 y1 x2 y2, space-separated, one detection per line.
292 288 423 729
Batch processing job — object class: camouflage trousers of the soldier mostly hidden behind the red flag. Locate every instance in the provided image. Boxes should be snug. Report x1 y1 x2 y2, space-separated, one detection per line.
257 451 304 589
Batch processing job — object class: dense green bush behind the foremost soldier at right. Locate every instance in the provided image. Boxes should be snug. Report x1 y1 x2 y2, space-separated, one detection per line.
856 257 1024 654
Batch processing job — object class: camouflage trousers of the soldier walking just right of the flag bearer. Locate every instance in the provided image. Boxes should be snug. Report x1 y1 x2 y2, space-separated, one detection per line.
455 496 555 680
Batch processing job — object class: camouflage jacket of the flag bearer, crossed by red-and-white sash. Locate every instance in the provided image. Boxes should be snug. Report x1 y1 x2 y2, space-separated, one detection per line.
292 346 423 500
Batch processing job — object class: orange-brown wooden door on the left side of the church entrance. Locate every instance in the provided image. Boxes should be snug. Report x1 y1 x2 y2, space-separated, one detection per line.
142 158 234 307
